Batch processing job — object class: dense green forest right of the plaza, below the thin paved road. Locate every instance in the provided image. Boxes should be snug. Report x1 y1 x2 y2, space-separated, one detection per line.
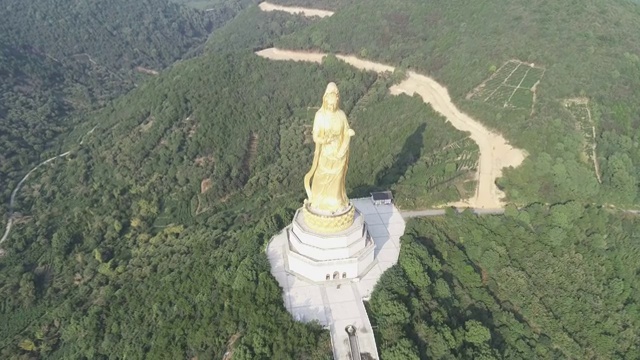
370 208 640 360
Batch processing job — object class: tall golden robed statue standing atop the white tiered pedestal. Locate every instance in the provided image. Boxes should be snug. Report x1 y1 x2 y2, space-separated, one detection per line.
304 83 355 222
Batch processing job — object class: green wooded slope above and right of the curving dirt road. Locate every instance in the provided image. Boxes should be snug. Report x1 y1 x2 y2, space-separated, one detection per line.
277 0 640 206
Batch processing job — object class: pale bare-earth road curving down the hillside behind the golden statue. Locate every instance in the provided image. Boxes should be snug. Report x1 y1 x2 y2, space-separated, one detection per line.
256 48 526 209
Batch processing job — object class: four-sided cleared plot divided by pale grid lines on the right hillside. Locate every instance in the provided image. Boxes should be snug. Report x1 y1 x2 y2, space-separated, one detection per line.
467 60 545 112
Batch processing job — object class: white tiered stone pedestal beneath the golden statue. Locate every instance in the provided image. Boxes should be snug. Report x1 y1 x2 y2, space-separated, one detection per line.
285 209 376 282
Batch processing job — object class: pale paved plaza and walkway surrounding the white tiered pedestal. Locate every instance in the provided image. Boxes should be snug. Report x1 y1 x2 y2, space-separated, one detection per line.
267 198 405 360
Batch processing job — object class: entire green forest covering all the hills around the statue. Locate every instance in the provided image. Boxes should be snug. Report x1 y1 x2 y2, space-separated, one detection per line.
0 0 640 360
